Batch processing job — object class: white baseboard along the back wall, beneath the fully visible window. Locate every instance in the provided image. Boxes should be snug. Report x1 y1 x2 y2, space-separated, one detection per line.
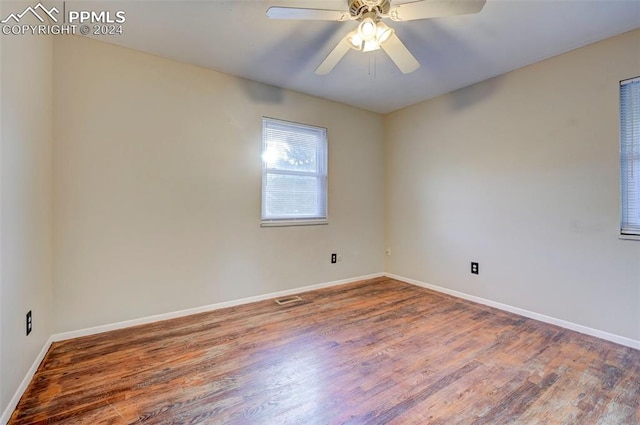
51 272 384 342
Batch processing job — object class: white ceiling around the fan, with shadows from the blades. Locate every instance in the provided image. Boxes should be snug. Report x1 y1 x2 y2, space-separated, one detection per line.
84 0 640 113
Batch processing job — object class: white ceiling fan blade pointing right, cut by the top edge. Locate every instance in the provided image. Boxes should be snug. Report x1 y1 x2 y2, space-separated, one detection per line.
389 0 487 21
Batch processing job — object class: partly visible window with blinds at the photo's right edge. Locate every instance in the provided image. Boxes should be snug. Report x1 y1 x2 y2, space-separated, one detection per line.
620 77 640 237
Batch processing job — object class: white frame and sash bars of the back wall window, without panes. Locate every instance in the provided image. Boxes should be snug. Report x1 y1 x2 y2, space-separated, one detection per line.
261 117 329 227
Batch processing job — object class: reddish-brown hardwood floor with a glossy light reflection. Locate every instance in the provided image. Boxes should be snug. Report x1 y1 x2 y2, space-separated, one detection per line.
9 278 640 425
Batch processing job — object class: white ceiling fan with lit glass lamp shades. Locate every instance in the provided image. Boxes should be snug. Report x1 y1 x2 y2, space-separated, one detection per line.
267 0 486 75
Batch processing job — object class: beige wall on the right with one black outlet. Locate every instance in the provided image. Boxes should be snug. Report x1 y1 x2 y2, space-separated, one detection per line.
385 30 640 340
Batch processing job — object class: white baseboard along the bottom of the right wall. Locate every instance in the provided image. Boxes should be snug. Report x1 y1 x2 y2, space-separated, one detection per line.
384 273 640 350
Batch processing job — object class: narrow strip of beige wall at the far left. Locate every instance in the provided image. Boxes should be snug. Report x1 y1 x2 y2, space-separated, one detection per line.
0 9 53 414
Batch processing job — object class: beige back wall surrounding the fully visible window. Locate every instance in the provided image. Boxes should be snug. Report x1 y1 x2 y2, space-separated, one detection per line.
53 37 384 332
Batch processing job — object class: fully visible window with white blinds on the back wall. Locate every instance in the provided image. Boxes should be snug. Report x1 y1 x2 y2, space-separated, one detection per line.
262 118 327 226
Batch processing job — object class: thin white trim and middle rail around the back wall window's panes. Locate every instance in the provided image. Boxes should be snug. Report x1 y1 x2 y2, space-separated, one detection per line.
260 117 329 227
